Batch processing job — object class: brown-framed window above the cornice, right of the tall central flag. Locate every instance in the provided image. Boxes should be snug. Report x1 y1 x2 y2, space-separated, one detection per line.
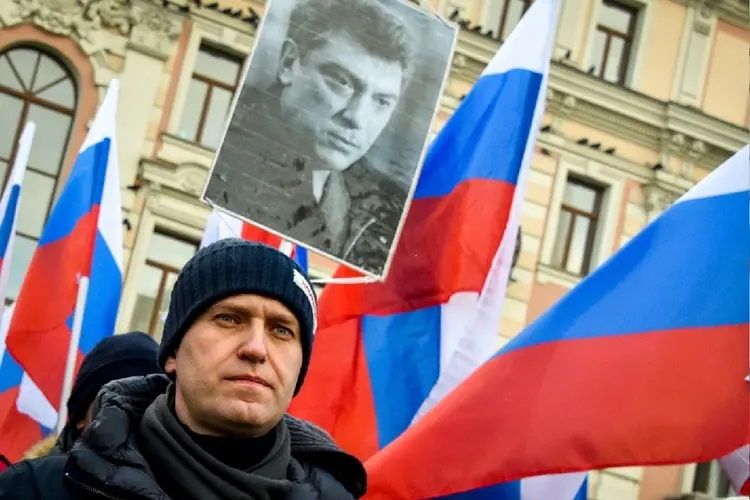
591 0 638 85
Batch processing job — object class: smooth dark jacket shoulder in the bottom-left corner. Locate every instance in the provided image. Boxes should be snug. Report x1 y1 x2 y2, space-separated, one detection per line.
0 456 68 500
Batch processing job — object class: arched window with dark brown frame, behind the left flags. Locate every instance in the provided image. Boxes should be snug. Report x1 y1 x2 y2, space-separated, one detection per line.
0 46 78 299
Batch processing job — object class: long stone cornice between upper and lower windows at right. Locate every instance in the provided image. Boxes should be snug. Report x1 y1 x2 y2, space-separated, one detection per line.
452 30 748 168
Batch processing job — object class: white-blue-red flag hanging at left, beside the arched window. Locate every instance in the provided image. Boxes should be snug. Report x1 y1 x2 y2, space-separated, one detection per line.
0 80 123 460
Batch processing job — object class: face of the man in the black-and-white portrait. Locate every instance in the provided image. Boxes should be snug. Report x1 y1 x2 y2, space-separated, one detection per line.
278 31 403 171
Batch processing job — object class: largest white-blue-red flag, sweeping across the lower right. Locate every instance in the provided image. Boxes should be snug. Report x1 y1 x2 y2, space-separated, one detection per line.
368 146 750 500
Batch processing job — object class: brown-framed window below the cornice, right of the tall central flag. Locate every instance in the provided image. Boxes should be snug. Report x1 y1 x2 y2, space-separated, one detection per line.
551 177 603 276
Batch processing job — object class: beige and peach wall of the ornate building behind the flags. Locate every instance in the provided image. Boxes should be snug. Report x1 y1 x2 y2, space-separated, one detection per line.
0 0 750 500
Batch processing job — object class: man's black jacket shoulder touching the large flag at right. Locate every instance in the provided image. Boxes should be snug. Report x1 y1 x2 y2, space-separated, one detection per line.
284 415 367 500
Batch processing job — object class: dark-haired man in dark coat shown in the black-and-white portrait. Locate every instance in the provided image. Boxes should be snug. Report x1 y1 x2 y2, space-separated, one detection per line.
213 0 414 274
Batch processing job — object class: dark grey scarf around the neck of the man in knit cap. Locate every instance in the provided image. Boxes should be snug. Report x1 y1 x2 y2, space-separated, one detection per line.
138 394 302 500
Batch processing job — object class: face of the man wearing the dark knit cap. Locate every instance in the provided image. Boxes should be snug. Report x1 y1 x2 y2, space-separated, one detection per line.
165 294 302 437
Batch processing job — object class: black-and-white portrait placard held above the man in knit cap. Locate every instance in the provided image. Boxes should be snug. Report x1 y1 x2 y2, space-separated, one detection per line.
203 0 456 280
